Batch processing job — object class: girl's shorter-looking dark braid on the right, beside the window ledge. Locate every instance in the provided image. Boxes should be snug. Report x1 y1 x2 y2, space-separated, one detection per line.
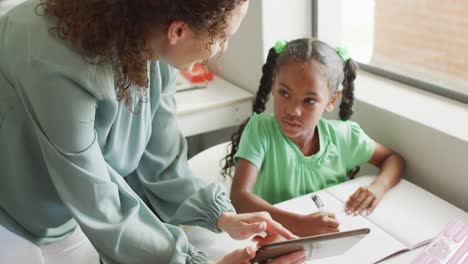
340 59 357 121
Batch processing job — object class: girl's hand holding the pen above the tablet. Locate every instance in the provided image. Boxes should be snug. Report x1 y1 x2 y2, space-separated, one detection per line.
294 212 340 237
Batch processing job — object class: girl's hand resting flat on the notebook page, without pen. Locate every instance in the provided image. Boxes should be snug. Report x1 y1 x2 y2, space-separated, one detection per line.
345 185 385 215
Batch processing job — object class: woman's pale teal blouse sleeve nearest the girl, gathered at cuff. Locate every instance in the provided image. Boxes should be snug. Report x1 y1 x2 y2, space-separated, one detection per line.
135 62 234 232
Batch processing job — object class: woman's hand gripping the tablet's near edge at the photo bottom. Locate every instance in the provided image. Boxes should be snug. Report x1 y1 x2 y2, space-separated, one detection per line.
208 247 306 264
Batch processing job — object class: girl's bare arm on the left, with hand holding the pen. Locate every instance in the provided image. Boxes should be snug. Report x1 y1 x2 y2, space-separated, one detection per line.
231 159 339 236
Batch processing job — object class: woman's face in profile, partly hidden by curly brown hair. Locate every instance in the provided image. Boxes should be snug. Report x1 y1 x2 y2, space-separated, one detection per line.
154 1 249 70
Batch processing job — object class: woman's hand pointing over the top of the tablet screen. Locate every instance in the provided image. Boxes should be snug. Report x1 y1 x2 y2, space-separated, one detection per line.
218 212 297 240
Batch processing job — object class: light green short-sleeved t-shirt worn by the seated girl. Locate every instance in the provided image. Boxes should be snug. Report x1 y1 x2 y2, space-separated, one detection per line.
235 114 375 204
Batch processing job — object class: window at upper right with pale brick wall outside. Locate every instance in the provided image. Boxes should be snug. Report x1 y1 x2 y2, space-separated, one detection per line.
313 0 468 103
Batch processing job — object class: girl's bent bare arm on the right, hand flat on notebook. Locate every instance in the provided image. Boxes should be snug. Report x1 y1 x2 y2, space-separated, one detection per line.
345 142 405 215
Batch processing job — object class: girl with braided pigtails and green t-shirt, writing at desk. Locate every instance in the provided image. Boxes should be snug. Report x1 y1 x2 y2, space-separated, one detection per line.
223 39 404 236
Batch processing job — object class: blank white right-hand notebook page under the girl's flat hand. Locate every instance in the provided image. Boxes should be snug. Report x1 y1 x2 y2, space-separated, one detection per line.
327 176 468 249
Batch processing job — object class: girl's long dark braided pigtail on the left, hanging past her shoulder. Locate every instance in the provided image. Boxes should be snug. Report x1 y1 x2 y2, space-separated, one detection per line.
221 48 278 178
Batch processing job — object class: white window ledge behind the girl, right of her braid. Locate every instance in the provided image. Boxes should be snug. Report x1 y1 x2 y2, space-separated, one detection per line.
355 71 468 142
